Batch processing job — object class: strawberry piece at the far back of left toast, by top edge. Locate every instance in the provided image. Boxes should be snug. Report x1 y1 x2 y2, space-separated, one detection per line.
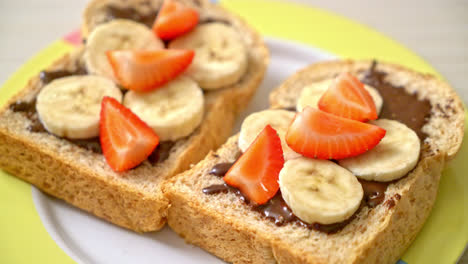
153 0 200 40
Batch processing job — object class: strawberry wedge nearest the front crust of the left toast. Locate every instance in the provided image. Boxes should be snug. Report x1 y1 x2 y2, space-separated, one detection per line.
99 96 159 172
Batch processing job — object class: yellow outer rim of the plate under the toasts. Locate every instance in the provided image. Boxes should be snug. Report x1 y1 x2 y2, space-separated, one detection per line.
0 0 468 263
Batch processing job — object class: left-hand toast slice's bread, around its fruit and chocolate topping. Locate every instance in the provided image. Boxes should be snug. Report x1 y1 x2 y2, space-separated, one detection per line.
0 0 269 232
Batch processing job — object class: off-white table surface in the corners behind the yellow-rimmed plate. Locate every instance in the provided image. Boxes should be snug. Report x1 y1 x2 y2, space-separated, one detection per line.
0 0 468 263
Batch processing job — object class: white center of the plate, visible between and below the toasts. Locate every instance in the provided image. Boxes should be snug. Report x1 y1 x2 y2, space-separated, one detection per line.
33 38 334 264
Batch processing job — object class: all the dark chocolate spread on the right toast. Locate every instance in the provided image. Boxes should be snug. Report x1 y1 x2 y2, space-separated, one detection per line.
203 61 431 234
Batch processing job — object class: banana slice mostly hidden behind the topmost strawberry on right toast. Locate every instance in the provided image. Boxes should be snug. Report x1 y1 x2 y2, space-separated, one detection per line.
296 79 383 114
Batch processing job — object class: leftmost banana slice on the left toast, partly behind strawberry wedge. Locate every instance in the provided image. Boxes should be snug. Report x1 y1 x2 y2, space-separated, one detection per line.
36 75 122 139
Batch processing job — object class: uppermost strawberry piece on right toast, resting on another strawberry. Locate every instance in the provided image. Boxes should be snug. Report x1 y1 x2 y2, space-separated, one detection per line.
318 73 377 121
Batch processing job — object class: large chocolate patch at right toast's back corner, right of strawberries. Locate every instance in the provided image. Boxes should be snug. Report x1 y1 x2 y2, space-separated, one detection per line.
362 61 431 141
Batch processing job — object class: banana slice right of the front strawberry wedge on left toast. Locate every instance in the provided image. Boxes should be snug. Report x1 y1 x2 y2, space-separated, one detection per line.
123 76 204 141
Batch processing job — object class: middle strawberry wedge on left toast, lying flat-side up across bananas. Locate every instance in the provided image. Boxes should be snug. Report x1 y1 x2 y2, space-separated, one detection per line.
106 49 195 92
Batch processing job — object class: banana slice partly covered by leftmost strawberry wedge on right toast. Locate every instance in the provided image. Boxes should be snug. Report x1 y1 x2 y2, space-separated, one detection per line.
238 110 301 160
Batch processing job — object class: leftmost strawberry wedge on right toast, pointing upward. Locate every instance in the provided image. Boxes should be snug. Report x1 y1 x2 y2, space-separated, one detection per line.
224 125 284 204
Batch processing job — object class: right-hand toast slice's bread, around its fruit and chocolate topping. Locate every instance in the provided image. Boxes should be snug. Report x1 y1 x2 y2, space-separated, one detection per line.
165 60 464 264
